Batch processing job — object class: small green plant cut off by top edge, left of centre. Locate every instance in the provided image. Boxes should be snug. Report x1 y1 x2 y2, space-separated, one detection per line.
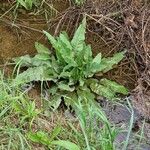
16 0 37 10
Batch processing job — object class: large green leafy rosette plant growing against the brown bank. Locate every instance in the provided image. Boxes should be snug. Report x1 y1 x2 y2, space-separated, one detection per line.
13 19 128 110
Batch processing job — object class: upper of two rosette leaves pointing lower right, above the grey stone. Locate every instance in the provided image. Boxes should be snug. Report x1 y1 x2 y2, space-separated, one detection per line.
100 78 128 95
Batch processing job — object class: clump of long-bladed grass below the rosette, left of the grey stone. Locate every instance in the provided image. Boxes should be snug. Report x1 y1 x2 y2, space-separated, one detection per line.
67 102 118 150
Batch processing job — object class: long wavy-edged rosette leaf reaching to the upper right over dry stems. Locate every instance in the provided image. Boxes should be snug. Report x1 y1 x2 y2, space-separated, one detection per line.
98 51 125 73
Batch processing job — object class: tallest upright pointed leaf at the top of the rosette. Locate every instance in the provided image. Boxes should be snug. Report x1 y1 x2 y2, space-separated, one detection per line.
71 18 86 51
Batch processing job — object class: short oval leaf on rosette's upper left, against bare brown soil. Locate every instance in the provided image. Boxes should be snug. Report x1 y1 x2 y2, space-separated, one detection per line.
35 42 51 55
